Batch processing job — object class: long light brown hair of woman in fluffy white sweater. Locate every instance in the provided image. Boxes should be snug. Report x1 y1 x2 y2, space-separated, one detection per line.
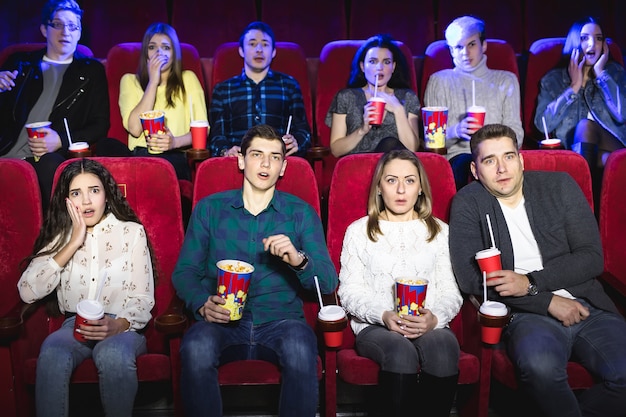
367 149 441 242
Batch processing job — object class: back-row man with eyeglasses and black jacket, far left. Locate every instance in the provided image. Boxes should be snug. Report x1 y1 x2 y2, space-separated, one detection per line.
0 0 109 208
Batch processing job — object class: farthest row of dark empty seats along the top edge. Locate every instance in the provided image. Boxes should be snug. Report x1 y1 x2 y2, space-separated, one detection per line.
0 0 626 57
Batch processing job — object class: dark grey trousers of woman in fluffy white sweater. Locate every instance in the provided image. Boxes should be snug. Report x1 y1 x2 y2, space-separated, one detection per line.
356 325 460 377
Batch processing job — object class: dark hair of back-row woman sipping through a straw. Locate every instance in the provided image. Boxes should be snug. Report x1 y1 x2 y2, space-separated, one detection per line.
348 34 411 88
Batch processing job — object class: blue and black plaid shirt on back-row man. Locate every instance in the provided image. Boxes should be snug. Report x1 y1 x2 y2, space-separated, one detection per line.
209 70 311 157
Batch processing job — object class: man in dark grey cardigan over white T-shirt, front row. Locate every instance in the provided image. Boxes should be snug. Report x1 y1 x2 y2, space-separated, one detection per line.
450 125 626 416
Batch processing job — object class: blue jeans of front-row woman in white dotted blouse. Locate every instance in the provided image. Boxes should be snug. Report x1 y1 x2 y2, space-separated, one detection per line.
35 317 146 417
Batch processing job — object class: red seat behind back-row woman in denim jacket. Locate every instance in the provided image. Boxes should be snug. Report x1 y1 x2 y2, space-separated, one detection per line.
522 37 624 148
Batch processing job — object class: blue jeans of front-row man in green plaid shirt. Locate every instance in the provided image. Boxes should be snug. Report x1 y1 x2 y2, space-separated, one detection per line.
180 311 318 417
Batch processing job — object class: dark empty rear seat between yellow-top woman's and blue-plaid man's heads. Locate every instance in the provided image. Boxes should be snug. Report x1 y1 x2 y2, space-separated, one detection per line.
171 0 257 58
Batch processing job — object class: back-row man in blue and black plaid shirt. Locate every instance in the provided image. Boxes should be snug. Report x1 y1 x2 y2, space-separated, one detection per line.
209 22 311 156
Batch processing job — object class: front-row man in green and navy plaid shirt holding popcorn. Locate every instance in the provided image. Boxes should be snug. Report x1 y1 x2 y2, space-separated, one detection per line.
172 125 337 417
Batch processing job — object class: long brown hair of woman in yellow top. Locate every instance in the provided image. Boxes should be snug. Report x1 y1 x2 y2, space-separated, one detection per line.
137 23 186 107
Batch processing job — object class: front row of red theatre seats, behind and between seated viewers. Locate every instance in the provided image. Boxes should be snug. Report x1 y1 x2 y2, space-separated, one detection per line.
0 150 626 417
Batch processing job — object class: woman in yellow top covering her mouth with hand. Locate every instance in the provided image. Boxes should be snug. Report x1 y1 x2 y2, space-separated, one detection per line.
119 23 208 179
